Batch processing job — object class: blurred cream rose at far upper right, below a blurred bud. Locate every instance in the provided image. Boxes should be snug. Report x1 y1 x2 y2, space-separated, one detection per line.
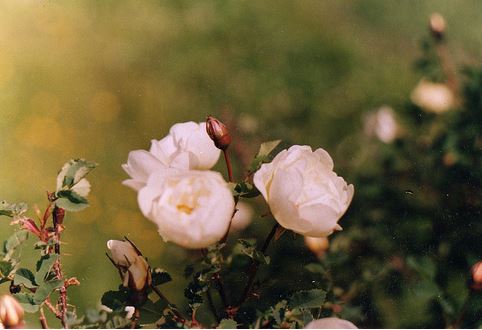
410 79 455 113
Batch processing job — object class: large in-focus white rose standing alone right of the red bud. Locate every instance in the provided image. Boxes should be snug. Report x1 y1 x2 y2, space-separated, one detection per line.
254 145 354 237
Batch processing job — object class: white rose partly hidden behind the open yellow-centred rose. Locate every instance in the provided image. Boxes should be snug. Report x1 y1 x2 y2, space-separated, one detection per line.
122 121 221 191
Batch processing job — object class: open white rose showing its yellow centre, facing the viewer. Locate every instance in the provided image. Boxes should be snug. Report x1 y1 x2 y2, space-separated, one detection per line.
138 169 234 249
